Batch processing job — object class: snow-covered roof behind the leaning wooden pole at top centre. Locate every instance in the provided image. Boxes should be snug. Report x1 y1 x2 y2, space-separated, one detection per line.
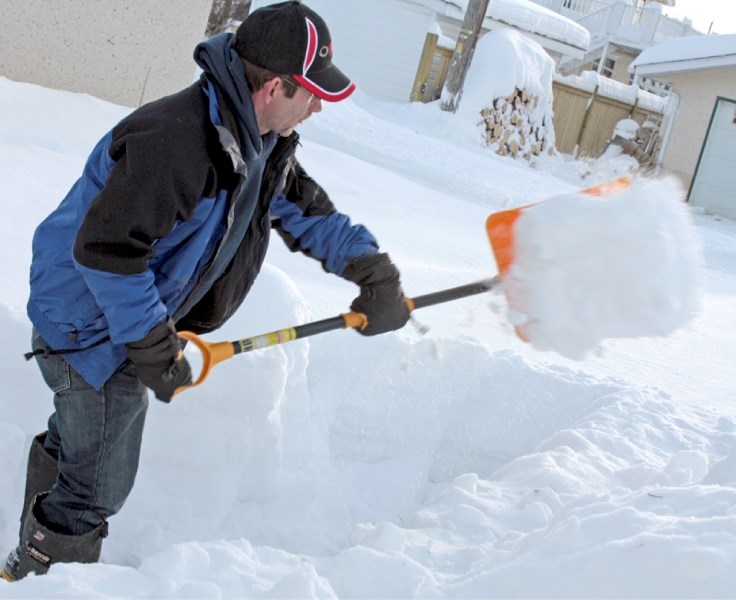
415 0 590 52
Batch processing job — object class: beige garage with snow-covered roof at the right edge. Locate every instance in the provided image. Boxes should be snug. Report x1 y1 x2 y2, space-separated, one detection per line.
632 35 736 219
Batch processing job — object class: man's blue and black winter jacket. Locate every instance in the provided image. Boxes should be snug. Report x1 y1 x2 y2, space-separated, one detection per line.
28 65 378 388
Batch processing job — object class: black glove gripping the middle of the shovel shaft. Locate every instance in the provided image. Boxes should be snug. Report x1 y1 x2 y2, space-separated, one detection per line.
343 253 409 335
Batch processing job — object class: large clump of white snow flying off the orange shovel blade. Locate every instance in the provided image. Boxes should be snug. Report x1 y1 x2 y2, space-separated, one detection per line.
504 178 701 359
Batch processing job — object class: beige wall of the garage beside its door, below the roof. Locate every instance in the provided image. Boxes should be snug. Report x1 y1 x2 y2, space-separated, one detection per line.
662 67 736 189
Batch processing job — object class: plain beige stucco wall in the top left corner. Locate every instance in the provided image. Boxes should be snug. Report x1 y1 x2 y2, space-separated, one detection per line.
0 0 212 107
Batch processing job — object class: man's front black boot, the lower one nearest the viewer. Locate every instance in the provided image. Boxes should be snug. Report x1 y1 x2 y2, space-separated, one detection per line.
2 493 107 581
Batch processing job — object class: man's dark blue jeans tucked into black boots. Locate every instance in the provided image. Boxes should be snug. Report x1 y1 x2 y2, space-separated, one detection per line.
33 330 148 535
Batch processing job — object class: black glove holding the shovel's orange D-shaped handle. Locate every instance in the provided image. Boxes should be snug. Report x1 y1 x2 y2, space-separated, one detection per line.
126 319 192 402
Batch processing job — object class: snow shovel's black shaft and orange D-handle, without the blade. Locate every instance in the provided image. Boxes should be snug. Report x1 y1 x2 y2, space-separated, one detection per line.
174 276 499 395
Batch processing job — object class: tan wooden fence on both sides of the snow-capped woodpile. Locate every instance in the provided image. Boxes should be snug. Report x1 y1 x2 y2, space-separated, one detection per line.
410 33 662 158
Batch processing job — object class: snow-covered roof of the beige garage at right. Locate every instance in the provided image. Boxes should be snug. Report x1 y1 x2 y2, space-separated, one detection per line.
629 34 736 75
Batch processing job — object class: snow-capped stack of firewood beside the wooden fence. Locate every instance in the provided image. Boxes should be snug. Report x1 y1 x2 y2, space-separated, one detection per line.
458 29 555 160
